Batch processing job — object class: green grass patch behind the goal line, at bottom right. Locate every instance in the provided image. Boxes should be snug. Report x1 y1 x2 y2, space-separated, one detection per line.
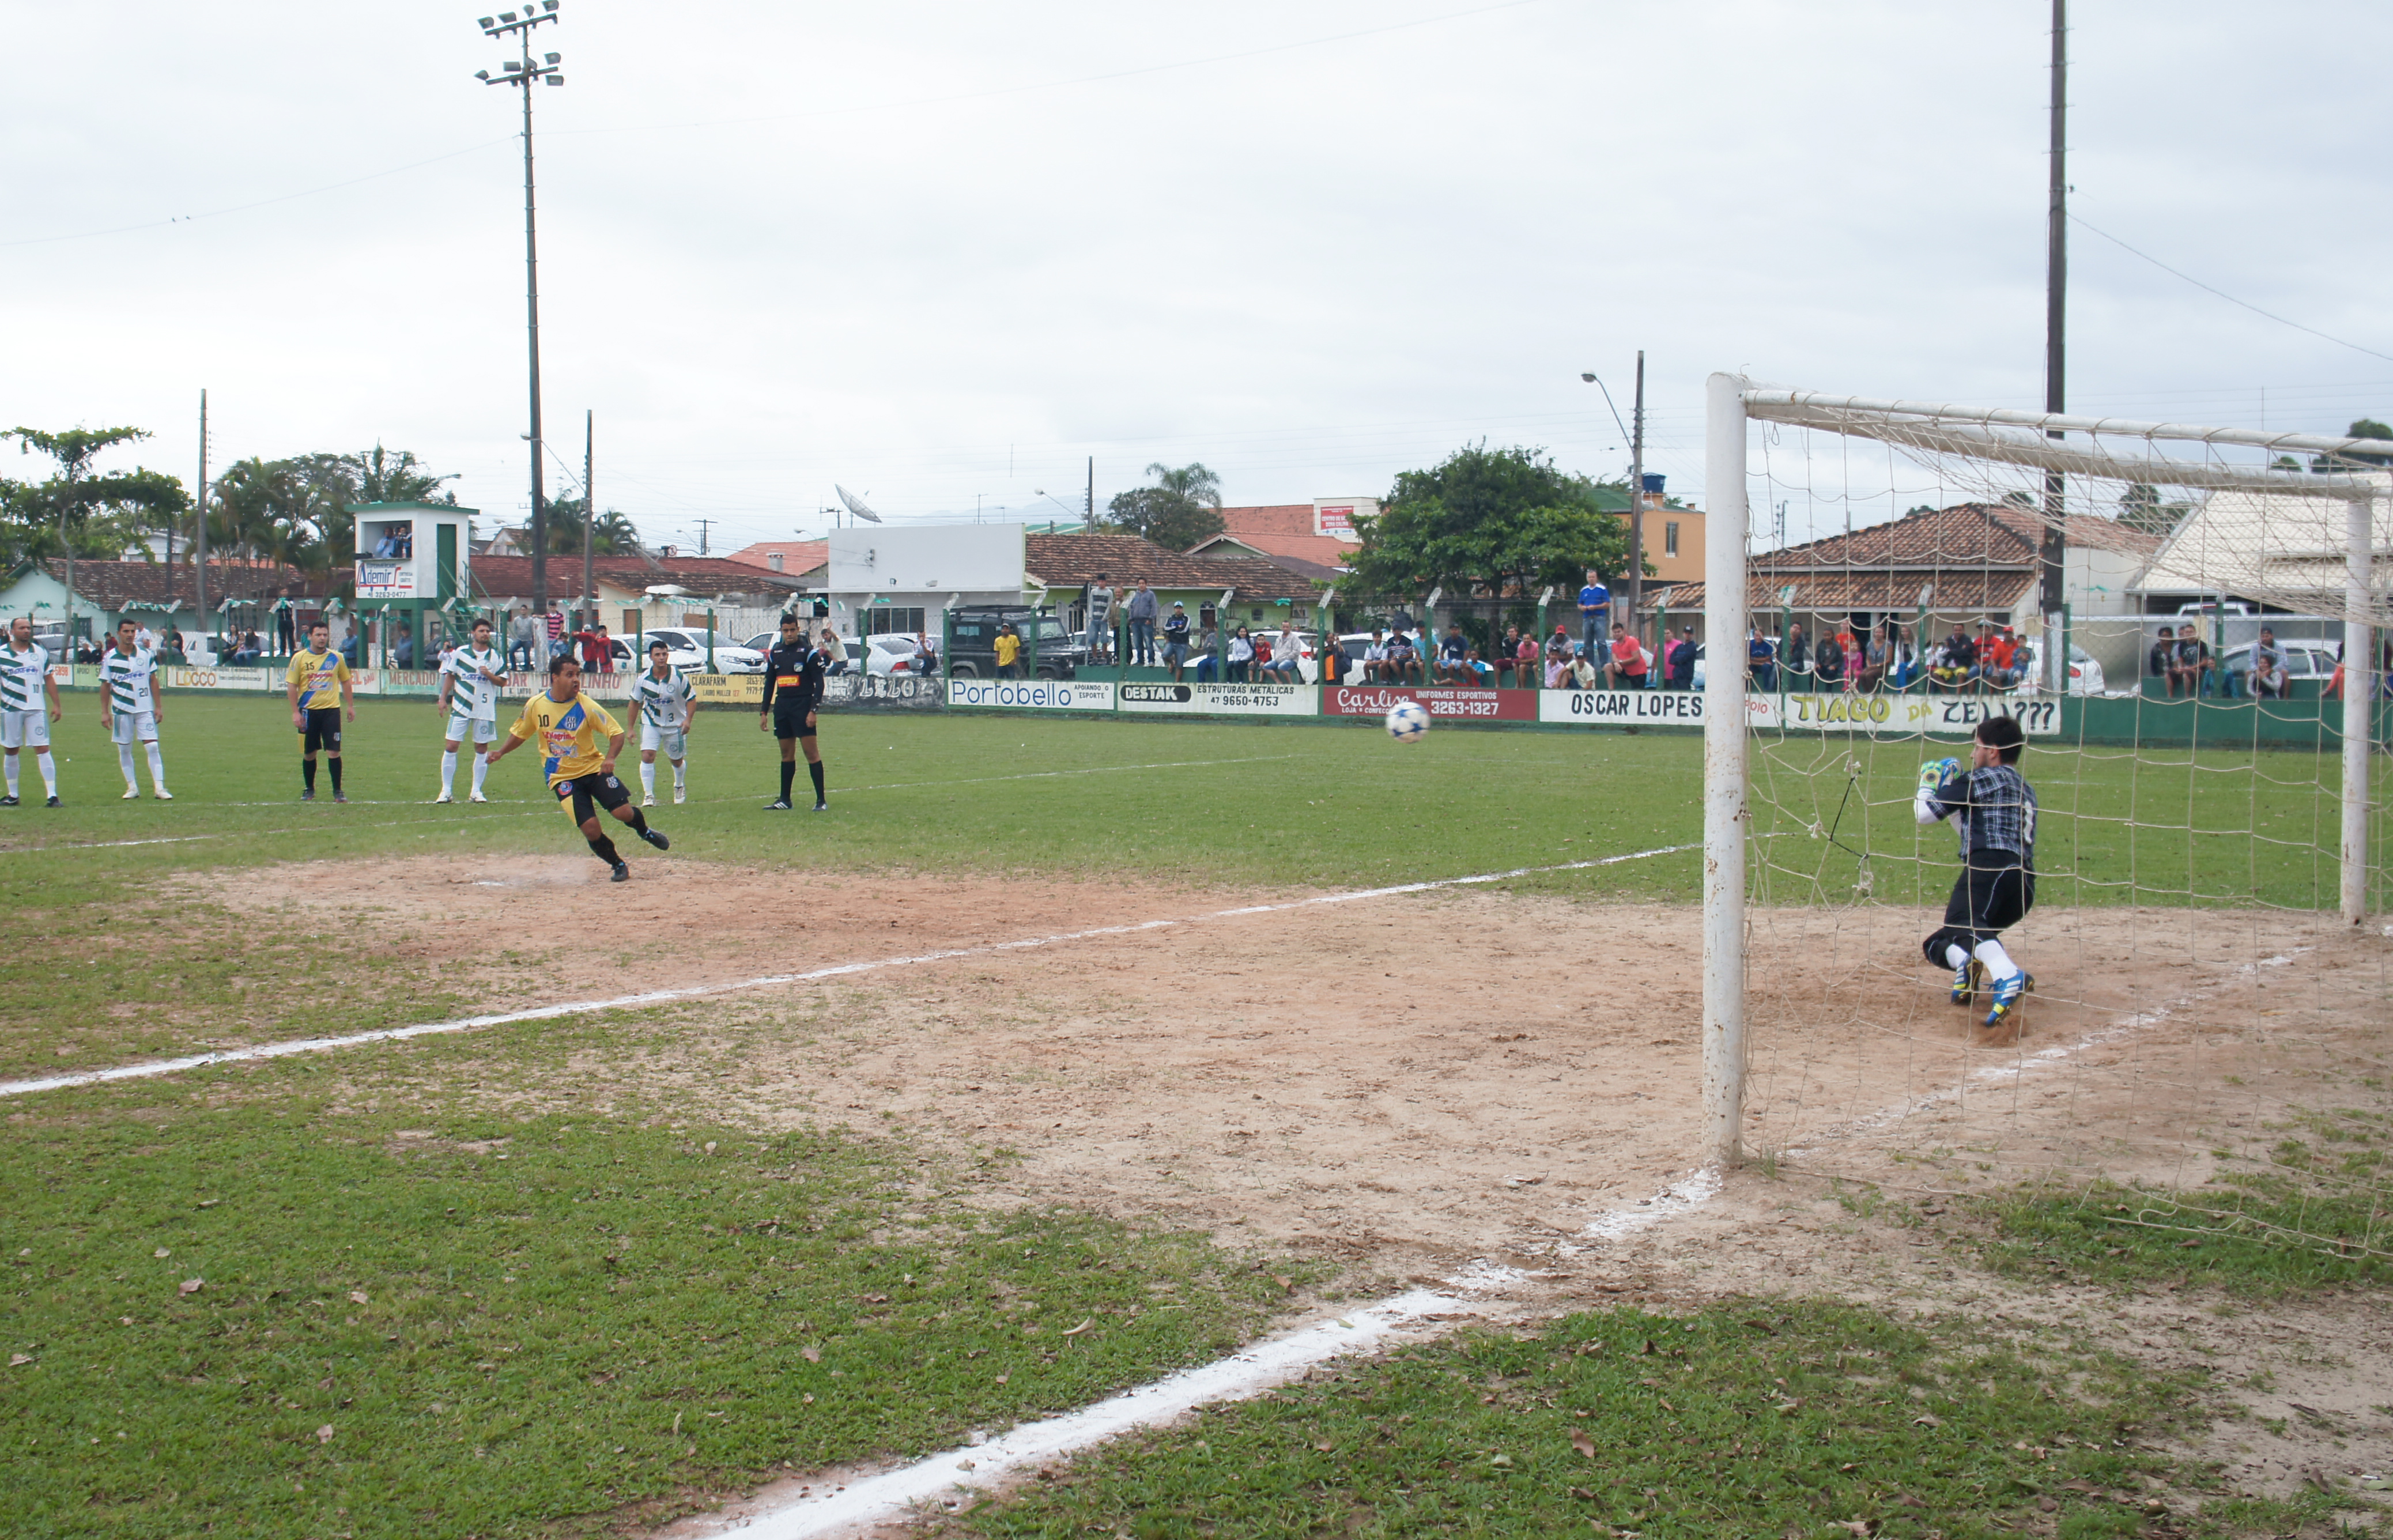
969 1301 2331 1540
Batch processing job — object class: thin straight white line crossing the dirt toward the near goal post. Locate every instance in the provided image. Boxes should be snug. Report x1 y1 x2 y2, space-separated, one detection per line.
0 844 1701 1097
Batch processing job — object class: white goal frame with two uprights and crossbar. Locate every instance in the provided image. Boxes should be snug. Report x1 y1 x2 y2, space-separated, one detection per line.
1704 373 2393 1165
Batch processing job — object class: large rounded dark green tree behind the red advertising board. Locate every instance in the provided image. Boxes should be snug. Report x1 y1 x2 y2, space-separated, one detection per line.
1340 443 1654 598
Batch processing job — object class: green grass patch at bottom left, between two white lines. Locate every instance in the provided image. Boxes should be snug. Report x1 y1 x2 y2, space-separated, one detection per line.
0 1056 1288 1538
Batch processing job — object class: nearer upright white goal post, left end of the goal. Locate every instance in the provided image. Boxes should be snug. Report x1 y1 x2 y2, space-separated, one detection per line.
1704 375 1749 1167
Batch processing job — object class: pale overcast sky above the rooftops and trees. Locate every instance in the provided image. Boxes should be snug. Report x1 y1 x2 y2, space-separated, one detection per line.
0 0 2393 552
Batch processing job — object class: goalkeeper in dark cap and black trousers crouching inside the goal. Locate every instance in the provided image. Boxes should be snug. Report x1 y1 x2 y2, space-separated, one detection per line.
1912 718 2036 1028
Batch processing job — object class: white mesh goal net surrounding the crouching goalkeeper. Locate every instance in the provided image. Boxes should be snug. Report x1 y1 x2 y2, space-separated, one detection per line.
1701 375 2393 1258
